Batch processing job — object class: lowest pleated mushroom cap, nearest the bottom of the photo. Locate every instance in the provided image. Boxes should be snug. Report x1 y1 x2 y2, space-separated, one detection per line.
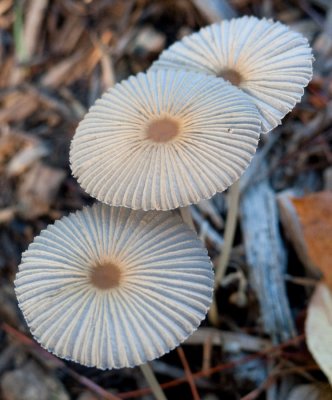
15 203 213 369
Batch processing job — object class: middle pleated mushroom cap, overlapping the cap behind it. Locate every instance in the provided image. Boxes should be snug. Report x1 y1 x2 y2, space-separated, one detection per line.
70 69 261 210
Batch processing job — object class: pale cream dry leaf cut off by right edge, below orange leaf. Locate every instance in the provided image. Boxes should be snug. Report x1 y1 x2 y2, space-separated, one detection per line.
305 283 332 384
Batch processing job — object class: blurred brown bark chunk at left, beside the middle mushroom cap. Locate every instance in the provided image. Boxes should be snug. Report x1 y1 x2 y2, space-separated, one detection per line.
17 163 66 219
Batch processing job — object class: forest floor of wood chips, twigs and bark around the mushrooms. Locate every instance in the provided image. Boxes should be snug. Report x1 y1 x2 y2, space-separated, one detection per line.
0 0 332 400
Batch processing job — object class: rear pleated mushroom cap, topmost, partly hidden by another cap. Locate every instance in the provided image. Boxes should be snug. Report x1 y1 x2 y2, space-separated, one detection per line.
151 16 313 133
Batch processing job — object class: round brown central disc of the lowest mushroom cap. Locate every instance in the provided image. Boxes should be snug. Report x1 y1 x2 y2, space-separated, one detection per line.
90 262 121 290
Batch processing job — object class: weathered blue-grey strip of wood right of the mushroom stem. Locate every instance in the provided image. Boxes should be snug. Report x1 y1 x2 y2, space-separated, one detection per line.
240 160 295 342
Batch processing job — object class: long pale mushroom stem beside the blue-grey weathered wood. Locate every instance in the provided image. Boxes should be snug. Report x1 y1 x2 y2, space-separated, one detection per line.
208 180 240 326
